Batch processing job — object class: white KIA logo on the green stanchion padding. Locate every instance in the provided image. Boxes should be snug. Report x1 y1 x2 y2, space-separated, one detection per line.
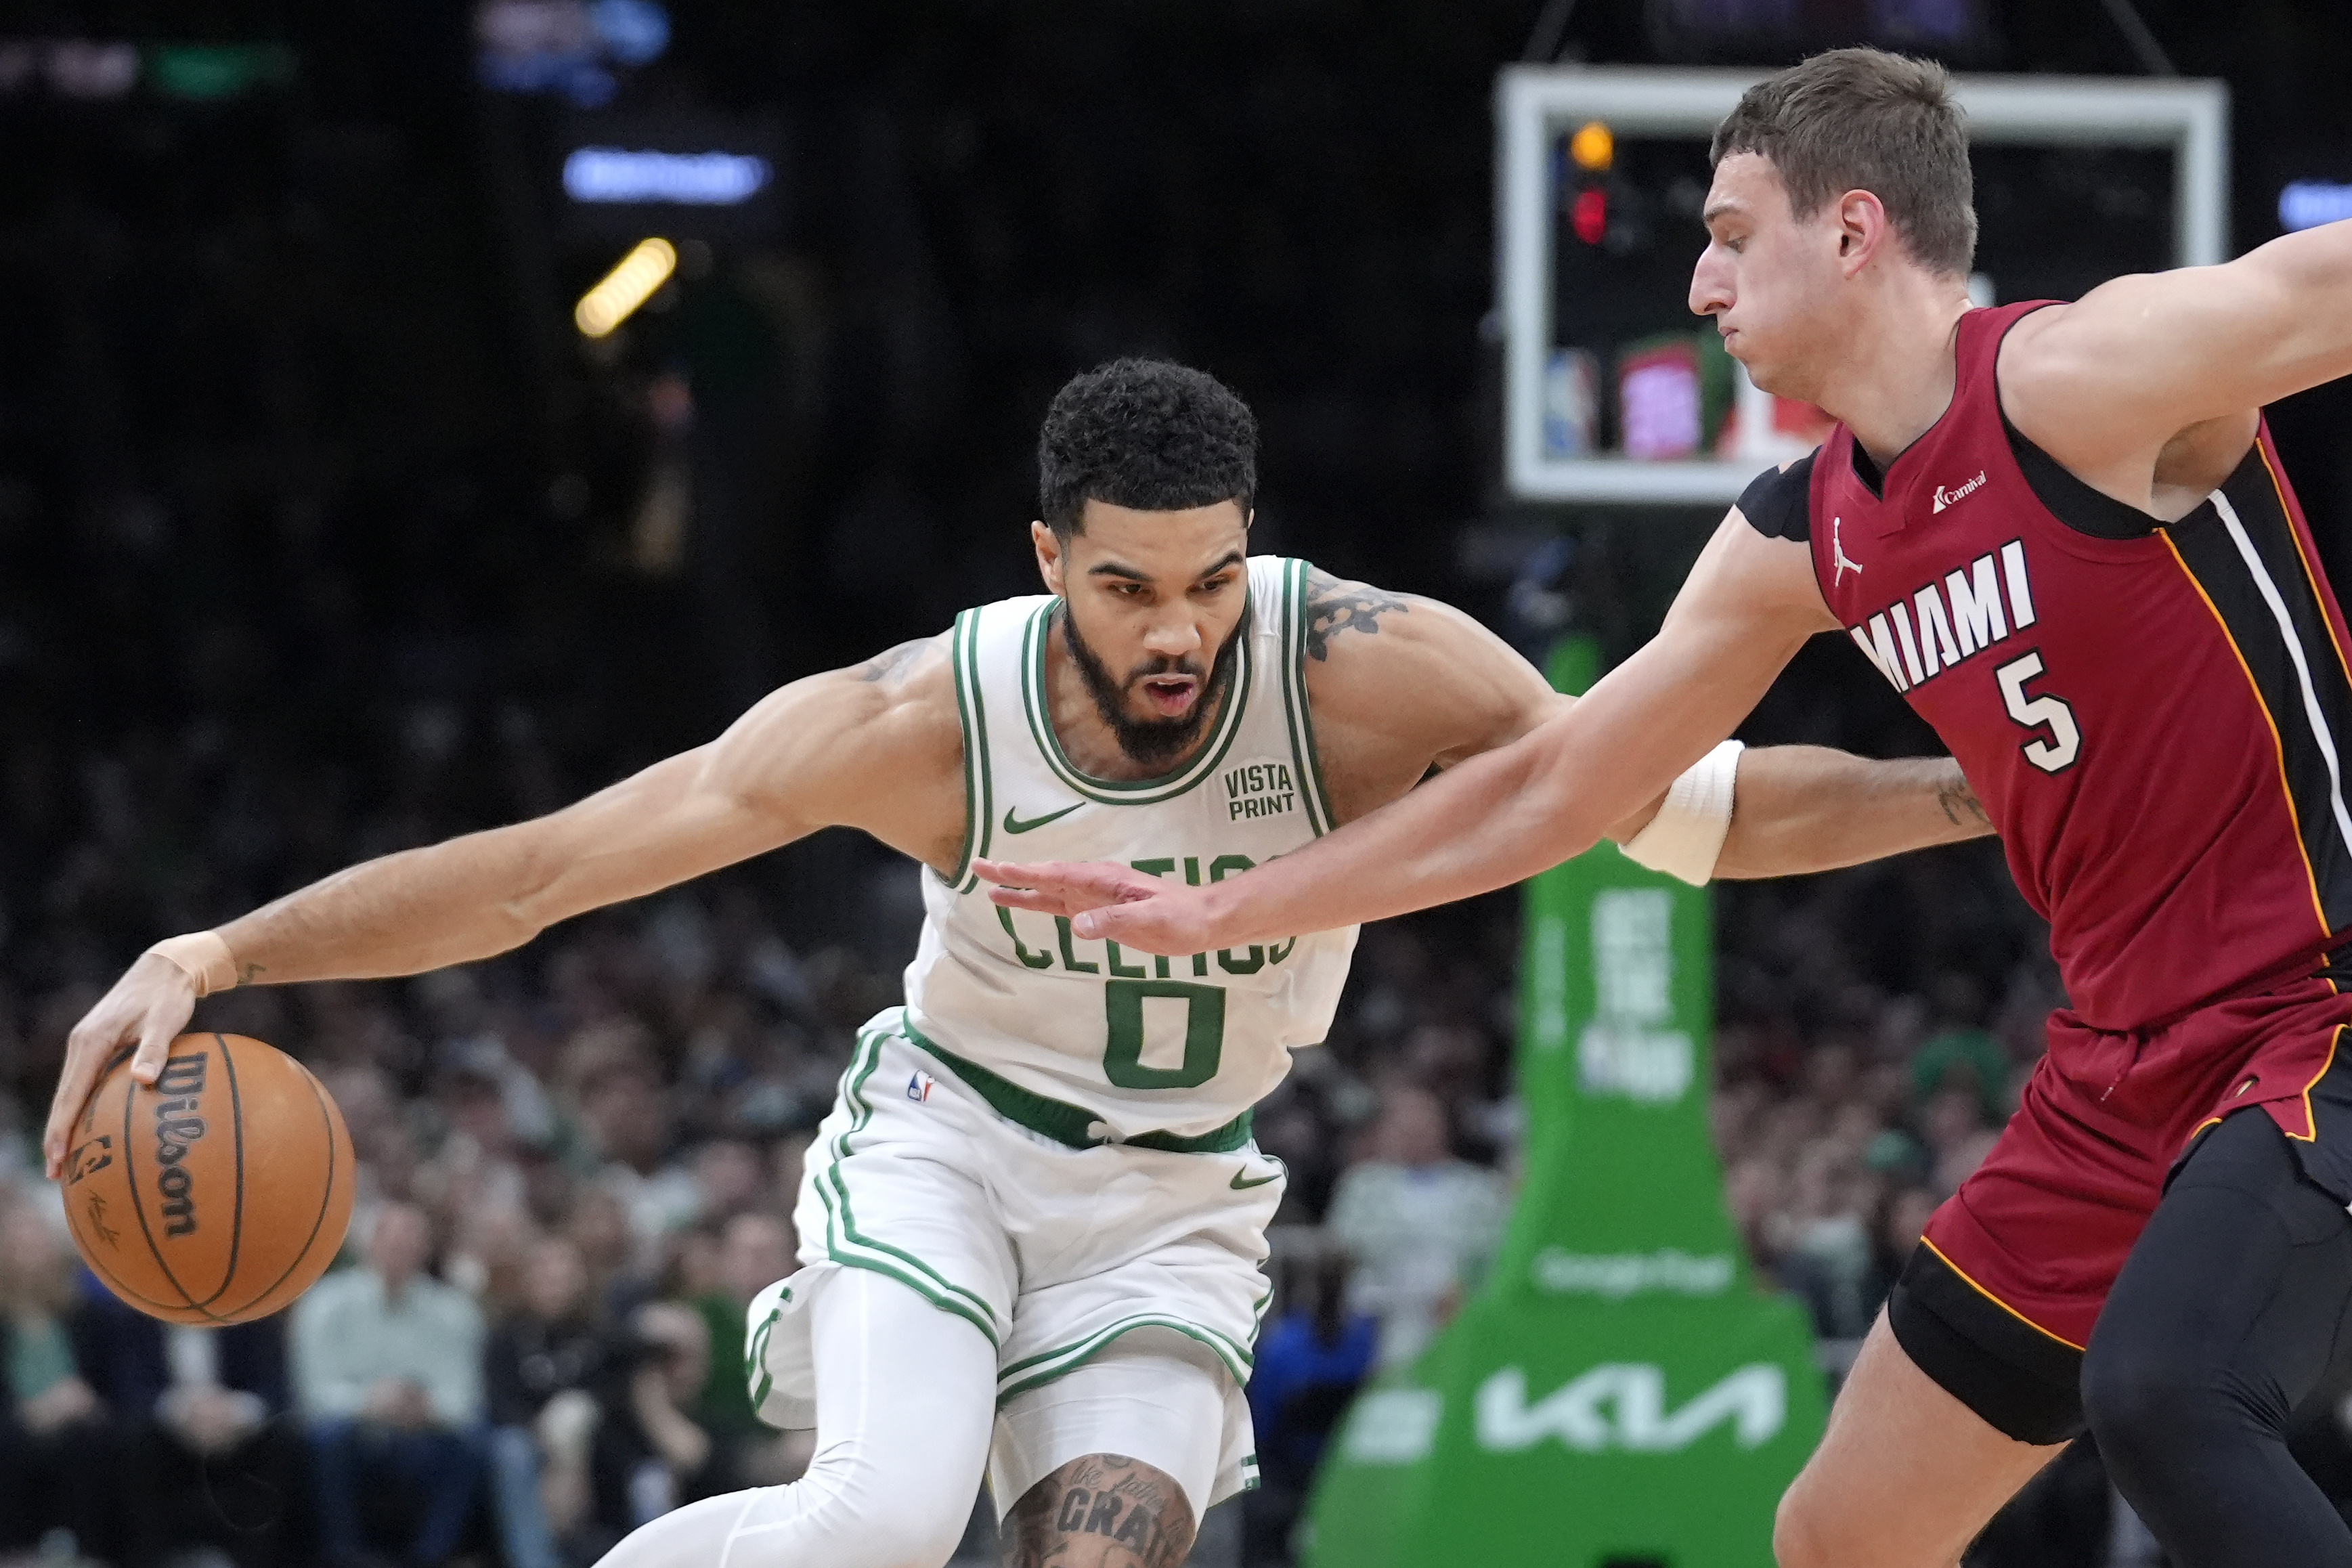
1477 1361 1787 1453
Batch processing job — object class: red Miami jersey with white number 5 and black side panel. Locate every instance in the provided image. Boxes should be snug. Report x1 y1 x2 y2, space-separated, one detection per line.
1790 301 2352 1030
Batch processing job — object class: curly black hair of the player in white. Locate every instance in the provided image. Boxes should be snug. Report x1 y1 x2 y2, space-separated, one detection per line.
1037 360 1259 538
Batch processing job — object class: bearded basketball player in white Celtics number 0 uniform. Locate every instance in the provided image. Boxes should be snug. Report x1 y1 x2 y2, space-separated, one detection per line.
47 360 1983 1568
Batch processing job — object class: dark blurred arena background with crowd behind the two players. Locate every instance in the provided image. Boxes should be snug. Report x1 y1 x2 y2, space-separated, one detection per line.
0 0 2352 1568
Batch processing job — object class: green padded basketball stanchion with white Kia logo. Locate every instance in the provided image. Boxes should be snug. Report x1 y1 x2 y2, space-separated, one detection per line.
1303 639 1827 1568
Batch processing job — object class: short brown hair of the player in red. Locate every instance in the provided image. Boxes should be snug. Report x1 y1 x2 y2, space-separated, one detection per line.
1707 49 1976 278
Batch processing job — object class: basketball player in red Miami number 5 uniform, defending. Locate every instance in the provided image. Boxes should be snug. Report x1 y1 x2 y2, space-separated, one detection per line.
986 49 2352 1568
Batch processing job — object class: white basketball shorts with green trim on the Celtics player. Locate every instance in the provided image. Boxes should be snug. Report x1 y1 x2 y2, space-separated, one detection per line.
745 1009 1284 1514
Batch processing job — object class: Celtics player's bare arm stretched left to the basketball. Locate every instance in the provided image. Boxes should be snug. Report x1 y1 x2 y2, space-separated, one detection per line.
45 637 962 1175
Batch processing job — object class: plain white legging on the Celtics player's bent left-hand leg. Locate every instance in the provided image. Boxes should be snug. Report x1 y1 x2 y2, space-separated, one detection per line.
597 1269 997 1568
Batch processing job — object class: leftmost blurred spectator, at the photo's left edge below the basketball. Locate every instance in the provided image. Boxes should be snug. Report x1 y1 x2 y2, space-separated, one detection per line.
0 1204 123 1559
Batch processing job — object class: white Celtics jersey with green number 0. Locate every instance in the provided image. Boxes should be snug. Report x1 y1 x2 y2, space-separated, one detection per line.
905 557 1355 1138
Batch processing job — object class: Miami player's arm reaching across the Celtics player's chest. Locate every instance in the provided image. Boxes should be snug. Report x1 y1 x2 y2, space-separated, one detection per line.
983 521 1835 955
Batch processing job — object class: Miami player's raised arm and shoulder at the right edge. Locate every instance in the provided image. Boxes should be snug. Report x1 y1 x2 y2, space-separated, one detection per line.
1999 221 2352 494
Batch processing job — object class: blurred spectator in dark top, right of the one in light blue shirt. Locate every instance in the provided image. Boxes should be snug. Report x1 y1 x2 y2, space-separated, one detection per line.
482 1236 626 1568
